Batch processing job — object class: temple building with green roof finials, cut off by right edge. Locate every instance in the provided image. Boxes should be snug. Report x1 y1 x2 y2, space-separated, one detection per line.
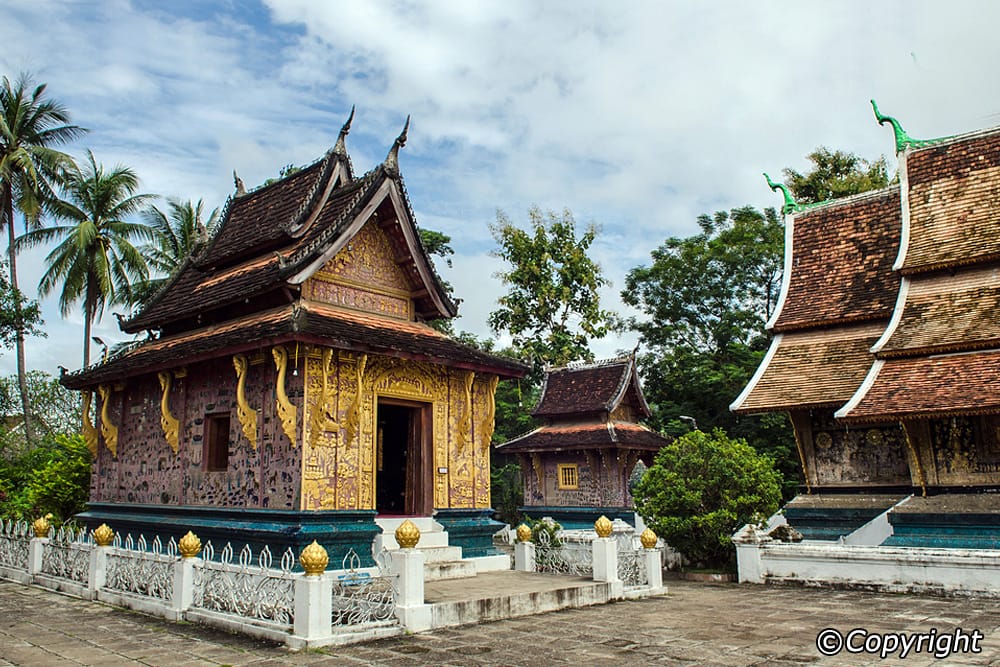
731 107 1000 564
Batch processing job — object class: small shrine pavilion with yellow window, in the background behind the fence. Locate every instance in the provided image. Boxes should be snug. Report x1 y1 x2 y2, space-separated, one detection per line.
497 355 670 528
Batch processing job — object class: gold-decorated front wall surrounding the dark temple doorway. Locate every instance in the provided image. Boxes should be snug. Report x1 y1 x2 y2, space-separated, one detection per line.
301 347 496 510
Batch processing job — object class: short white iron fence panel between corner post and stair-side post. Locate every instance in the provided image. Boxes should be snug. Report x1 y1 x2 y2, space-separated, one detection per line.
330 549 397 626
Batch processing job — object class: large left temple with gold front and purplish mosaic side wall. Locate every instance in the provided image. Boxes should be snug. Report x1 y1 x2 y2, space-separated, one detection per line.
62 111 526 562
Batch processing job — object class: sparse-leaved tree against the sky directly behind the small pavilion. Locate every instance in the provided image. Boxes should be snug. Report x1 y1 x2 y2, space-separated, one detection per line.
489 207 615 370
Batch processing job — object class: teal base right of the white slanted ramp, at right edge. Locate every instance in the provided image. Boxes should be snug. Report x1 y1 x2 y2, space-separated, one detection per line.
882 512 1000 549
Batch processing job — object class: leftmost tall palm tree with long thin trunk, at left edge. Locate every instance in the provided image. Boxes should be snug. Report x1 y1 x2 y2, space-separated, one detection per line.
0 74 86 442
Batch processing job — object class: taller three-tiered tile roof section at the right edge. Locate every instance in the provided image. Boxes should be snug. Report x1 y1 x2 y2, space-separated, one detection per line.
837 129 1000 421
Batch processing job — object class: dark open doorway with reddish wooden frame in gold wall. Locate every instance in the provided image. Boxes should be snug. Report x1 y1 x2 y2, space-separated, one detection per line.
375 398 433 516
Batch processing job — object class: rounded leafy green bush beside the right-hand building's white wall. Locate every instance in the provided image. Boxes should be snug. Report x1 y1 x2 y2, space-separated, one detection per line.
634 429 781 569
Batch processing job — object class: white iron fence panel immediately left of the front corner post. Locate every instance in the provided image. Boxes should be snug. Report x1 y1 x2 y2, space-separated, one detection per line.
192 542 295 630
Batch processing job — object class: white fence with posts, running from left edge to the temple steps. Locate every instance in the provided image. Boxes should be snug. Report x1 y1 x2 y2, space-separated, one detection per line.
0 520 406 648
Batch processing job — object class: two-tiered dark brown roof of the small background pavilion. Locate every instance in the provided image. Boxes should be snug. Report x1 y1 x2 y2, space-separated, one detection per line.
498 355 670 454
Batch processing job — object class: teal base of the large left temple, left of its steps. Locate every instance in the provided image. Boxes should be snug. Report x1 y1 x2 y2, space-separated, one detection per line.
76 503 382 569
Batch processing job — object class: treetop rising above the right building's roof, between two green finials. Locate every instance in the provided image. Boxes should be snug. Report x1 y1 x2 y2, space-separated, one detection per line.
782 146 889 204
